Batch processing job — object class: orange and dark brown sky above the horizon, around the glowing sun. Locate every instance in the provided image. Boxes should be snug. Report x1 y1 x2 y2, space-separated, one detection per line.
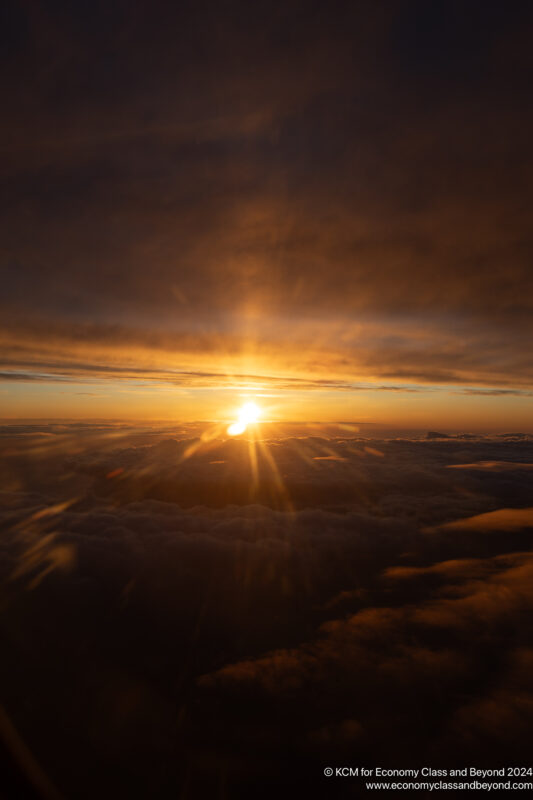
0 0 533 430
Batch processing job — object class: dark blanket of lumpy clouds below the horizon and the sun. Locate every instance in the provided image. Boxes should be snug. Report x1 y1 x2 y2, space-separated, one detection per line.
0 423 533 798
